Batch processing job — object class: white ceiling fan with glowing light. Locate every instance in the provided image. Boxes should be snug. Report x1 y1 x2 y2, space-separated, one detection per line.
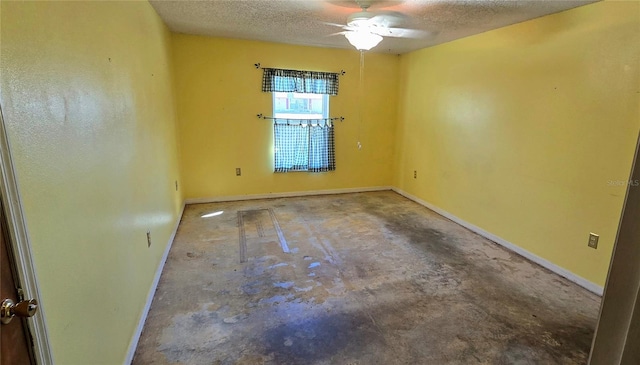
327 0 427 51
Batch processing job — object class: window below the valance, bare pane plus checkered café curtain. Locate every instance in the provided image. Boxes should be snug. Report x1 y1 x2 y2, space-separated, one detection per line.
273 92 335 172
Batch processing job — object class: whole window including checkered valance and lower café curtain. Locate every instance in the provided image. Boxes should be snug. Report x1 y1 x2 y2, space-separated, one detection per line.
262 68 338 172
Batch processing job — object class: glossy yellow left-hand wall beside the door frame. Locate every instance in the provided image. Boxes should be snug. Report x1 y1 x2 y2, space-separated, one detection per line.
0 1 182 365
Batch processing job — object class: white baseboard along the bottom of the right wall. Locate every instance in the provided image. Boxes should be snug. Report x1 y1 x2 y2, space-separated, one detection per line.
391 187 604 296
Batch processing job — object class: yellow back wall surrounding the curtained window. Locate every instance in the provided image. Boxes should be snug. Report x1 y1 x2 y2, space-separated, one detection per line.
173 34 398 199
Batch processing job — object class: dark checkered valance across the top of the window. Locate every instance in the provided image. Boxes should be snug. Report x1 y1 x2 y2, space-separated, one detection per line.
262 68 340 96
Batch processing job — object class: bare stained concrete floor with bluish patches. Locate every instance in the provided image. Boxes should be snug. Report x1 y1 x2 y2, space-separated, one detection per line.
133 192 600 365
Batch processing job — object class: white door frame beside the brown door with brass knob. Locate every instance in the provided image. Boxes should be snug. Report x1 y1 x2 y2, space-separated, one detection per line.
0 105 54 365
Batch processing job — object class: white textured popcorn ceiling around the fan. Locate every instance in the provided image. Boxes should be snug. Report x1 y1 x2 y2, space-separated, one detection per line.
150 0 596 53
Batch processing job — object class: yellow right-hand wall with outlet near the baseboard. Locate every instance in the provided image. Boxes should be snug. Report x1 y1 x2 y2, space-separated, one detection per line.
394 2 640 285
